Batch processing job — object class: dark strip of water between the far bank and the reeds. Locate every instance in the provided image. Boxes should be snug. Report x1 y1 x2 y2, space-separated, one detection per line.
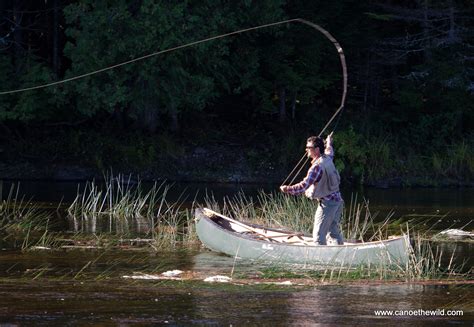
0 181 474 222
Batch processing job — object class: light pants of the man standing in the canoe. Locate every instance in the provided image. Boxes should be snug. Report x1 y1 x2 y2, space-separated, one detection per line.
313 200 344 245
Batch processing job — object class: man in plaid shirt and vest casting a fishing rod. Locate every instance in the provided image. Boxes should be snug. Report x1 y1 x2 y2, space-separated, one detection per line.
280 133 344 245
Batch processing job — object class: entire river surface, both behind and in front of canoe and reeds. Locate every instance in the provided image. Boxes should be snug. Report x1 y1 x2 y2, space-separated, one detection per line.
0 181 474 327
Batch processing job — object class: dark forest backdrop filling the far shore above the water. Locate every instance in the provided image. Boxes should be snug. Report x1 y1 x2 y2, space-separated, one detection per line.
0 0 474 187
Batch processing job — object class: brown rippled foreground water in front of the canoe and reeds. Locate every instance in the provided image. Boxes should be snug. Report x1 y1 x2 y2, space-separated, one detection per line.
0 251 474 326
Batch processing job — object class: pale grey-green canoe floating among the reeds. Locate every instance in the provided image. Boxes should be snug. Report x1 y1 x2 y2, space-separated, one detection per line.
195 208 411 267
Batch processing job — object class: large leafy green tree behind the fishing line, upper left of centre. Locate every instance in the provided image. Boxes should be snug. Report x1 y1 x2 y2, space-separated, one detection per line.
65 0 286 132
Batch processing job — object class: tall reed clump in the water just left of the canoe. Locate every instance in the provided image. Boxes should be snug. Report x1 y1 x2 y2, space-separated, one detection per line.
68 174 197 249
